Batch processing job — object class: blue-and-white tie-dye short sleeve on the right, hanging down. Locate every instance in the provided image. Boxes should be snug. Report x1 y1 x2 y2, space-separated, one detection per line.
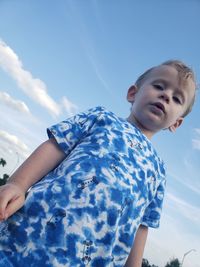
141 177 166 228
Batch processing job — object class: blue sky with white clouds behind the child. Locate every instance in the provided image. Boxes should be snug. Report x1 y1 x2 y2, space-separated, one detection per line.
0 0 200 267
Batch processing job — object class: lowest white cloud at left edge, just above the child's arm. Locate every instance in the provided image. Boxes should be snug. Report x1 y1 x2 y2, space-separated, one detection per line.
0 130 30 158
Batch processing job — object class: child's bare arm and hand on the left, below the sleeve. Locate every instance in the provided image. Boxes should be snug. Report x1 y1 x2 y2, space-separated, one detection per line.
0 138 66 220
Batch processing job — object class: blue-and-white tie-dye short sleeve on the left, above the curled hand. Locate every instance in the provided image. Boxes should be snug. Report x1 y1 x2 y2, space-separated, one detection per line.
47 107 104 155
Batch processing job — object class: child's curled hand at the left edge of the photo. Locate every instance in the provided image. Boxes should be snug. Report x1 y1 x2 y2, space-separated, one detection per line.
0 183 25 221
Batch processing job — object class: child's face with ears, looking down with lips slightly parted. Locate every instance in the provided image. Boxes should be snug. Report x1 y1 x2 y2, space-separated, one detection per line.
127 65 195 138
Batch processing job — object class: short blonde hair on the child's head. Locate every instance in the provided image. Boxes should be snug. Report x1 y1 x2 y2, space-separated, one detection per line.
135 60 196 117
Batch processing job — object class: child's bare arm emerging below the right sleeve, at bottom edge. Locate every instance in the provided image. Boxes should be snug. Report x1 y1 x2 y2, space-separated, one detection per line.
124 225 148 267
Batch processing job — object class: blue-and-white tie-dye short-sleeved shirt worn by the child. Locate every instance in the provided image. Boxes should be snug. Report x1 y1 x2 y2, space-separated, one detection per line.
0 107 165 267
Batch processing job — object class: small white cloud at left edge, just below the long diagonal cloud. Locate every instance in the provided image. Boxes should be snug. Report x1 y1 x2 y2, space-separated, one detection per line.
0 92 30 113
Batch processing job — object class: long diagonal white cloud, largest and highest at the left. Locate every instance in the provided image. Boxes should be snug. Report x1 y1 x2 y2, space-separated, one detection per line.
0 40 77 116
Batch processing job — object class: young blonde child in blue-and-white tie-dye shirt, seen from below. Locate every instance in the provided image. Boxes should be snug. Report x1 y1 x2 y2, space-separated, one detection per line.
0 60 195 267
